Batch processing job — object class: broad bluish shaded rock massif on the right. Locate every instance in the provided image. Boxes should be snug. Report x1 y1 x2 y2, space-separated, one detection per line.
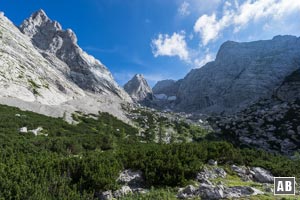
176 36 300 113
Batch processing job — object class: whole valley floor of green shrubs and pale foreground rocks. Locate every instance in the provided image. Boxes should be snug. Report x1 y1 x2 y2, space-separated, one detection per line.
0 105 300 200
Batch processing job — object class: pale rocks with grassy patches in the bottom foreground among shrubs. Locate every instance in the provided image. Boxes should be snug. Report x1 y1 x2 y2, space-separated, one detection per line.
97 160 298 200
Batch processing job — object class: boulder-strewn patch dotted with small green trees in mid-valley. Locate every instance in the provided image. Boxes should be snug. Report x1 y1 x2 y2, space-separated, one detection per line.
129 107 210 143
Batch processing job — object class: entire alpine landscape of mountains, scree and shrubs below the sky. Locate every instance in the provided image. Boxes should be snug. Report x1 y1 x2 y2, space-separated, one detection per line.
0 10 300 200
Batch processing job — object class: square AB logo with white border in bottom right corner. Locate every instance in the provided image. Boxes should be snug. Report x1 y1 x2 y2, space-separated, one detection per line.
274 177 295 195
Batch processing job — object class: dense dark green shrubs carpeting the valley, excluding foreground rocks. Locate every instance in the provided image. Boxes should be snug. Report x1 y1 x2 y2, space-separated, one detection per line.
0 106 300 199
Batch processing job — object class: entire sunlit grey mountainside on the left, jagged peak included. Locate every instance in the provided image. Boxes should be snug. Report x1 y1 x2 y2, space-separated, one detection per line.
0 11 131 120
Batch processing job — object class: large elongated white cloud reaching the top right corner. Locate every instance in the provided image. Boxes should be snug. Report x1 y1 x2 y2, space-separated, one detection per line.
194 0 300 45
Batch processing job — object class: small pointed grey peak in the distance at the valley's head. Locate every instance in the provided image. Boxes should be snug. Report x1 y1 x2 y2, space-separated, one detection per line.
124 74 152 103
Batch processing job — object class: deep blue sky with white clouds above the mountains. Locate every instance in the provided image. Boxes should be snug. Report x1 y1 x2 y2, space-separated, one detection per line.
0 0 300 85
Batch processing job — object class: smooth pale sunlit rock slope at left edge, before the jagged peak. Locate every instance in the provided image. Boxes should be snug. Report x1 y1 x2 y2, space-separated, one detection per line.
0 11 85 105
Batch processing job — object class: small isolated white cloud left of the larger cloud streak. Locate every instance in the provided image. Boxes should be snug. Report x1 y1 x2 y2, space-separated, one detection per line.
151 31 189 61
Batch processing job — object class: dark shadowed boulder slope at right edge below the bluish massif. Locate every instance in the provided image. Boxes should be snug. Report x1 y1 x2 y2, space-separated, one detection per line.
210 99 300 156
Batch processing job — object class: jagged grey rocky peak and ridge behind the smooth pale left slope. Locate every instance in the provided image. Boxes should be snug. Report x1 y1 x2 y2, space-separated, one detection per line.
20 10 128 99
